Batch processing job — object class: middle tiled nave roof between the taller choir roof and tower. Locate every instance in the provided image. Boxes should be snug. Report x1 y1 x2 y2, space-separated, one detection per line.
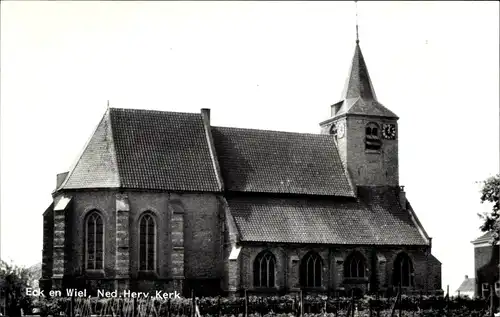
212 127 355 197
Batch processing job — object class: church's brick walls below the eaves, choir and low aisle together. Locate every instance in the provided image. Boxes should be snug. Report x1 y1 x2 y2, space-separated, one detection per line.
44 191 442 292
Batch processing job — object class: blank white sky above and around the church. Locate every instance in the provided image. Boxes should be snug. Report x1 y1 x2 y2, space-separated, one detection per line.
0 1 500 291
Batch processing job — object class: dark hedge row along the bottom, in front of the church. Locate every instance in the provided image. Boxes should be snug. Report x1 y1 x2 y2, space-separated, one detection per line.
29 295 488 317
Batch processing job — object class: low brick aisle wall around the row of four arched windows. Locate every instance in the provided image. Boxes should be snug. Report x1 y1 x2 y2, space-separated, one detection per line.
234 244 441 293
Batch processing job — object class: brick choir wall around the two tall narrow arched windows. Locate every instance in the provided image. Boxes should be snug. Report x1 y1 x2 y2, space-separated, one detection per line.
48 190 223 291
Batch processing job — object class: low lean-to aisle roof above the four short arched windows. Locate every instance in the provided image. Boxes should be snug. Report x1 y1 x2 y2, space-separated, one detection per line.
227 188 429 245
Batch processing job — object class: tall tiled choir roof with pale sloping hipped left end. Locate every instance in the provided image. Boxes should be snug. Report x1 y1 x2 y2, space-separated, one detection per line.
60 108 221 191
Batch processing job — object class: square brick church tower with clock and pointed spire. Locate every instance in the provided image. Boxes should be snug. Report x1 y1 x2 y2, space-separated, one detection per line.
320 38 399 186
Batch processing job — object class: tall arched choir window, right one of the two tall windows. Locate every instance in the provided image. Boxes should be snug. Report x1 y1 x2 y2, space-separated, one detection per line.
139 212 156 271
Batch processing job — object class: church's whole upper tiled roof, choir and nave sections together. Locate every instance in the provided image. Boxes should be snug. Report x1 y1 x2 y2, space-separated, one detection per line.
58 108 355 197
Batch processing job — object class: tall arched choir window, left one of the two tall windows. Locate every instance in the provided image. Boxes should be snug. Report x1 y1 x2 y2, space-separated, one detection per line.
85 211 104 270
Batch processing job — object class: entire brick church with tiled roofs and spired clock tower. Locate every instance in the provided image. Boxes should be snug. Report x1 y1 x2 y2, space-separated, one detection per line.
40 41 441 295
